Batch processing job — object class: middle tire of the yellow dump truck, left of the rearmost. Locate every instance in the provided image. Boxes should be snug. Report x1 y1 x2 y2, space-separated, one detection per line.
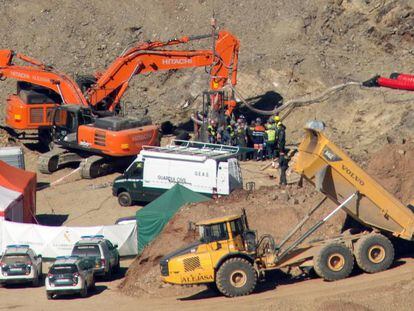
313 243 354 281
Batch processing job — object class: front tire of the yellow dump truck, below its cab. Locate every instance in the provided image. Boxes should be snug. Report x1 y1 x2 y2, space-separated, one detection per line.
216 258 257 297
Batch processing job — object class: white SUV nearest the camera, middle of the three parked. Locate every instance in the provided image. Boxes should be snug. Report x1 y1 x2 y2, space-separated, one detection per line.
45 256 95 299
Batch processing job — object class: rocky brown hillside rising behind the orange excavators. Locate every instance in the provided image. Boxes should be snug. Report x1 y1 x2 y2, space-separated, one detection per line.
0 0 414 160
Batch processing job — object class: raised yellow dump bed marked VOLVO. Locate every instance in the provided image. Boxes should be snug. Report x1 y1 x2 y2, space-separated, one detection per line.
295 121 414 240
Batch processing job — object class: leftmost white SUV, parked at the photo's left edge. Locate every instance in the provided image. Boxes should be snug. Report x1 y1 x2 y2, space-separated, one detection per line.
0 245 42 286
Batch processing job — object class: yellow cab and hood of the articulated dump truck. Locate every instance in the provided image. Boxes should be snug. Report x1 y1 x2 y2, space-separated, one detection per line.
160 215 256 288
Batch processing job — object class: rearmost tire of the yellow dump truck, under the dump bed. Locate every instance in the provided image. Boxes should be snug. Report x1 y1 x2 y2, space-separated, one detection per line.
355 234 394 273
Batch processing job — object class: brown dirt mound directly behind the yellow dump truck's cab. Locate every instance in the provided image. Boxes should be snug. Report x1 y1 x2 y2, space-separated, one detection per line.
120 186 345 296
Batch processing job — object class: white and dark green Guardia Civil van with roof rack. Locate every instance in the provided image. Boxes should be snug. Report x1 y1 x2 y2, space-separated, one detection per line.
113 141 243 206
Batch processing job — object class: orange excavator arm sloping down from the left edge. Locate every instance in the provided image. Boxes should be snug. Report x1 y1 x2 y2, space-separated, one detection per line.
0 50 88 107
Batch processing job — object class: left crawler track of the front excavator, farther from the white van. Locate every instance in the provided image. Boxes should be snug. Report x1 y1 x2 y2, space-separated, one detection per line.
37 147 82 174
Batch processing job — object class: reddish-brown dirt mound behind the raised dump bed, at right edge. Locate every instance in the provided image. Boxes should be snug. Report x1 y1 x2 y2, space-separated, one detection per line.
367 142 414 204
